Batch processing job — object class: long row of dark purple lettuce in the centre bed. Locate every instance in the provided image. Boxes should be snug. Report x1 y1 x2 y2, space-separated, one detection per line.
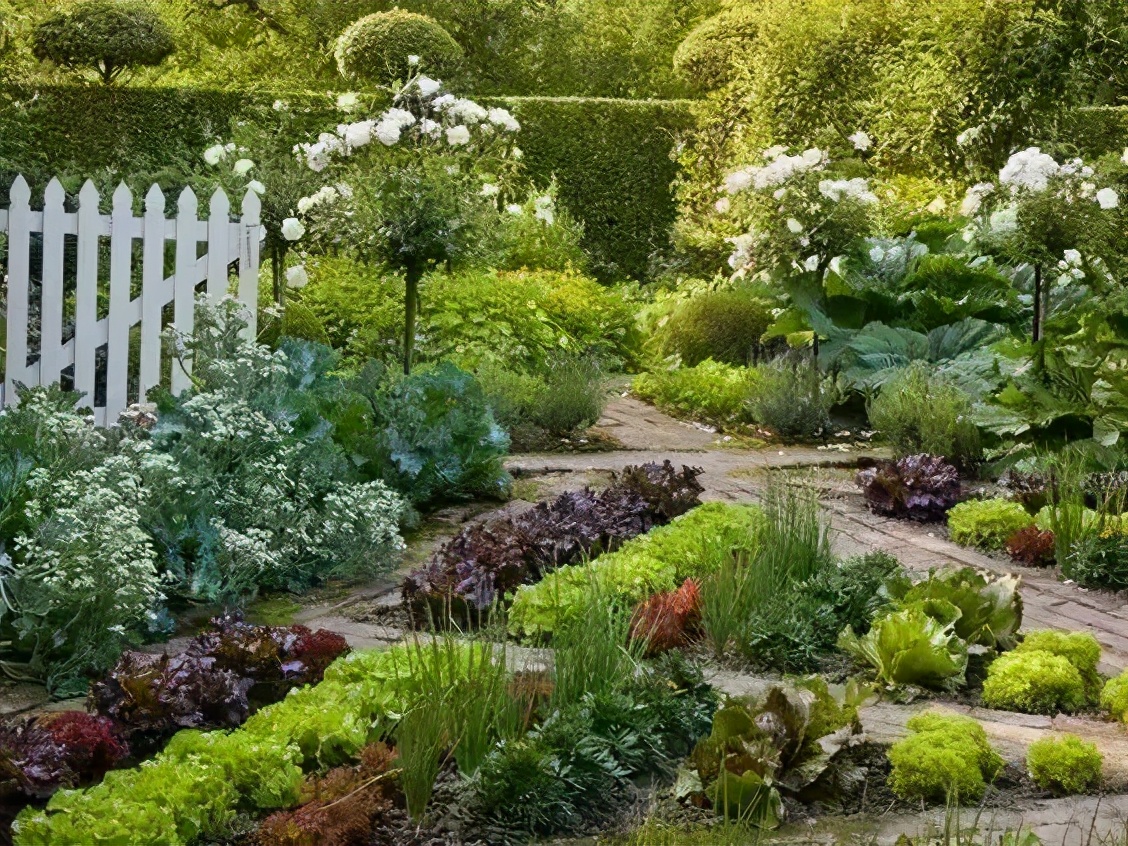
404 461 704 617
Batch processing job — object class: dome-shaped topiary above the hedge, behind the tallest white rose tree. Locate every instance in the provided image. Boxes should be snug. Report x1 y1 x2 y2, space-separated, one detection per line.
334 9 462 85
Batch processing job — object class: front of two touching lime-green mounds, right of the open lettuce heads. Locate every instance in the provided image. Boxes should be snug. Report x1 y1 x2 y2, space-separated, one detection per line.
984 650 1087 715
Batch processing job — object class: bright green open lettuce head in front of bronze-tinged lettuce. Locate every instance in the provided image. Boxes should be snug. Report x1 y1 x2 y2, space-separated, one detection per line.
838 602 968 689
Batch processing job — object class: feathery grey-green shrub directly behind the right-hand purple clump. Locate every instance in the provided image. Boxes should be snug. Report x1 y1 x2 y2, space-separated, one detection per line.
867 367 981 468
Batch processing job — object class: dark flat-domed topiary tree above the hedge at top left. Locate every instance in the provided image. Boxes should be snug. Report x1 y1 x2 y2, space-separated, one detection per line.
33 0 176 86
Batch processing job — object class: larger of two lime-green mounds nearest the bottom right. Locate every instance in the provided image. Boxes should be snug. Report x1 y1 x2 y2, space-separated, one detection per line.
888 711 1003 802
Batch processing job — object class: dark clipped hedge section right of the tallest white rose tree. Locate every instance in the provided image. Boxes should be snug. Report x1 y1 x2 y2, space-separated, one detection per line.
500 97 694 279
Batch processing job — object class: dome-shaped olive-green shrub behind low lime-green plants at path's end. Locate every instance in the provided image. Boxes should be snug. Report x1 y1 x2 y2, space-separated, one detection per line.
651 285 775 368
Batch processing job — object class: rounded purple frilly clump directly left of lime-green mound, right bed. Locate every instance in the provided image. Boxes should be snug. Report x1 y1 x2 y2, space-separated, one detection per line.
857 455 960 522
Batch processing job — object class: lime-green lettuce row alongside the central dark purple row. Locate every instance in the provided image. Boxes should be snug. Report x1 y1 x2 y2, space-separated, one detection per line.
509 503 764 636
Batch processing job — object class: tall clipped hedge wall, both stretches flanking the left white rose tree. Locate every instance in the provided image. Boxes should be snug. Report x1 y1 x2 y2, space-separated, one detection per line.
0 86 694 279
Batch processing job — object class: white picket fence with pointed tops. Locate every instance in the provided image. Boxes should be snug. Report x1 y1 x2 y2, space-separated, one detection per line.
0 176 262 425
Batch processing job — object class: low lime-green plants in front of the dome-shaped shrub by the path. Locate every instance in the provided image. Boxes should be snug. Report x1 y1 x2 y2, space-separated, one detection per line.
631 359 761 426
